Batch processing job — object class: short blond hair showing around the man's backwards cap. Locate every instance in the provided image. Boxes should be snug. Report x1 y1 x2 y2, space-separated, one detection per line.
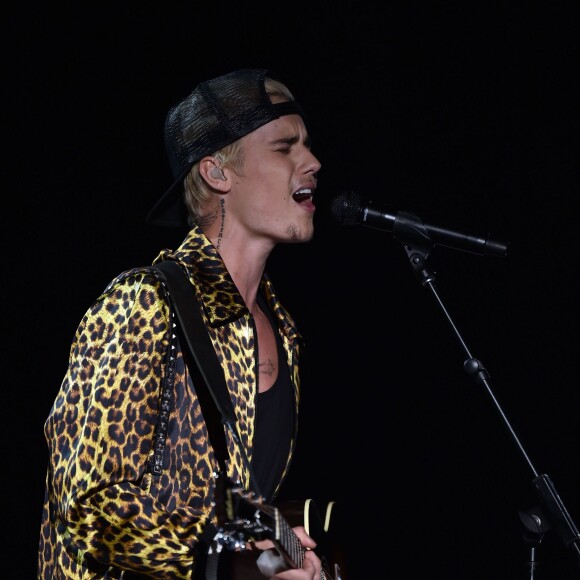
183 77 294 225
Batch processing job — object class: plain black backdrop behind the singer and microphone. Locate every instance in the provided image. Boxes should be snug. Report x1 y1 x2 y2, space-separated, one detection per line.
1 1 580 580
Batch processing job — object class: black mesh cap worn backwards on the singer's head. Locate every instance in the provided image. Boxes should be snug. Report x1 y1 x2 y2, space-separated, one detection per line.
146 69 304 227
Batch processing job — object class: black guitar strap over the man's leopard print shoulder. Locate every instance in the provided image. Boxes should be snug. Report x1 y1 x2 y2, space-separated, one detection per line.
153 260 259 494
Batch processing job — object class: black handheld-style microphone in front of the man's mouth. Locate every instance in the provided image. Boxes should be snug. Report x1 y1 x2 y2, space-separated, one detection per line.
331 191 508 257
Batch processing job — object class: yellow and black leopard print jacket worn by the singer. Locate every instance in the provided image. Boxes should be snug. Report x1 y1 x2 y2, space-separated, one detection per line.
38 227 301 580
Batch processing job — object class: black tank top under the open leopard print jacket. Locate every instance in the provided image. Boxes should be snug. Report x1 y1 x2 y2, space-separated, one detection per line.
252 297 294 501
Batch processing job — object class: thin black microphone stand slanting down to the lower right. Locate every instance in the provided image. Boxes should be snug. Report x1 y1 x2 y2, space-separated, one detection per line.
393 212 580 580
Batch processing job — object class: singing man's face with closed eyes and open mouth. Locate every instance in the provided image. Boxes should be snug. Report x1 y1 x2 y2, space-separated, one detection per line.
228 115 320 244
